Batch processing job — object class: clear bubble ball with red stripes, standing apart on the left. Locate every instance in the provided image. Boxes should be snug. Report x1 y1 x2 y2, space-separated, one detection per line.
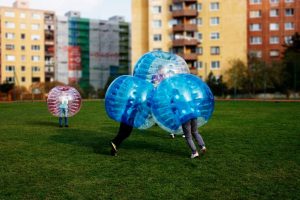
47 86 81 117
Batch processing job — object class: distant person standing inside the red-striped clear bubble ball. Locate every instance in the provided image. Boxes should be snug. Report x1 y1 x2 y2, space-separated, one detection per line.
58 91 70 127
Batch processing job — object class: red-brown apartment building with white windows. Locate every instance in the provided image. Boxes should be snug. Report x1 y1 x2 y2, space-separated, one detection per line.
247 0 300 62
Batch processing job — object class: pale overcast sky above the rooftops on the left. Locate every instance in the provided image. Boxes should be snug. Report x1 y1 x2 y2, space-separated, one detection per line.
0 0 131 22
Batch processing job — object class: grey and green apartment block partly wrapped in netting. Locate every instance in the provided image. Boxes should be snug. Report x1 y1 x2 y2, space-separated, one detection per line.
55 11 130 90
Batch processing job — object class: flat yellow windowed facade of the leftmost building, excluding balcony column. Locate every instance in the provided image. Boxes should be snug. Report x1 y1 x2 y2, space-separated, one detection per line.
0 7 45 88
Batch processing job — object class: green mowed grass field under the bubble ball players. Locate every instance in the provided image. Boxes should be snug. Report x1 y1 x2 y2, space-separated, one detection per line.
0 101 300 200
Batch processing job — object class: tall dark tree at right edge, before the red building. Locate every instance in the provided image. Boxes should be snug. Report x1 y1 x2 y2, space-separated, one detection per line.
283 33 300 92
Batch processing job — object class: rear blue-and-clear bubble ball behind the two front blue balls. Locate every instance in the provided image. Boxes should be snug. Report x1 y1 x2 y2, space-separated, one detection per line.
133 51 190 87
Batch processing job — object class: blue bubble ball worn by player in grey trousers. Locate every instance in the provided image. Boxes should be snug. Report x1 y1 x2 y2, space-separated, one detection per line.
151 74 214 134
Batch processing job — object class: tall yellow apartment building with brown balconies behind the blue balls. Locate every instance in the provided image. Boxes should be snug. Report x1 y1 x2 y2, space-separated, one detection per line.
132 0 247 78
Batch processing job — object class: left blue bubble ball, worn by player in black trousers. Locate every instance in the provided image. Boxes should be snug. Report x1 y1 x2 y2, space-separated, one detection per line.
105 75 155 129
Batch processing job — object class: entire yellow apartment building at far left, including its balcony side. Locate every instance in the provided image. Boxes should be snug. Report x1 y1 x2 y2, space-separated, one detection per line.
0 0 54 88
